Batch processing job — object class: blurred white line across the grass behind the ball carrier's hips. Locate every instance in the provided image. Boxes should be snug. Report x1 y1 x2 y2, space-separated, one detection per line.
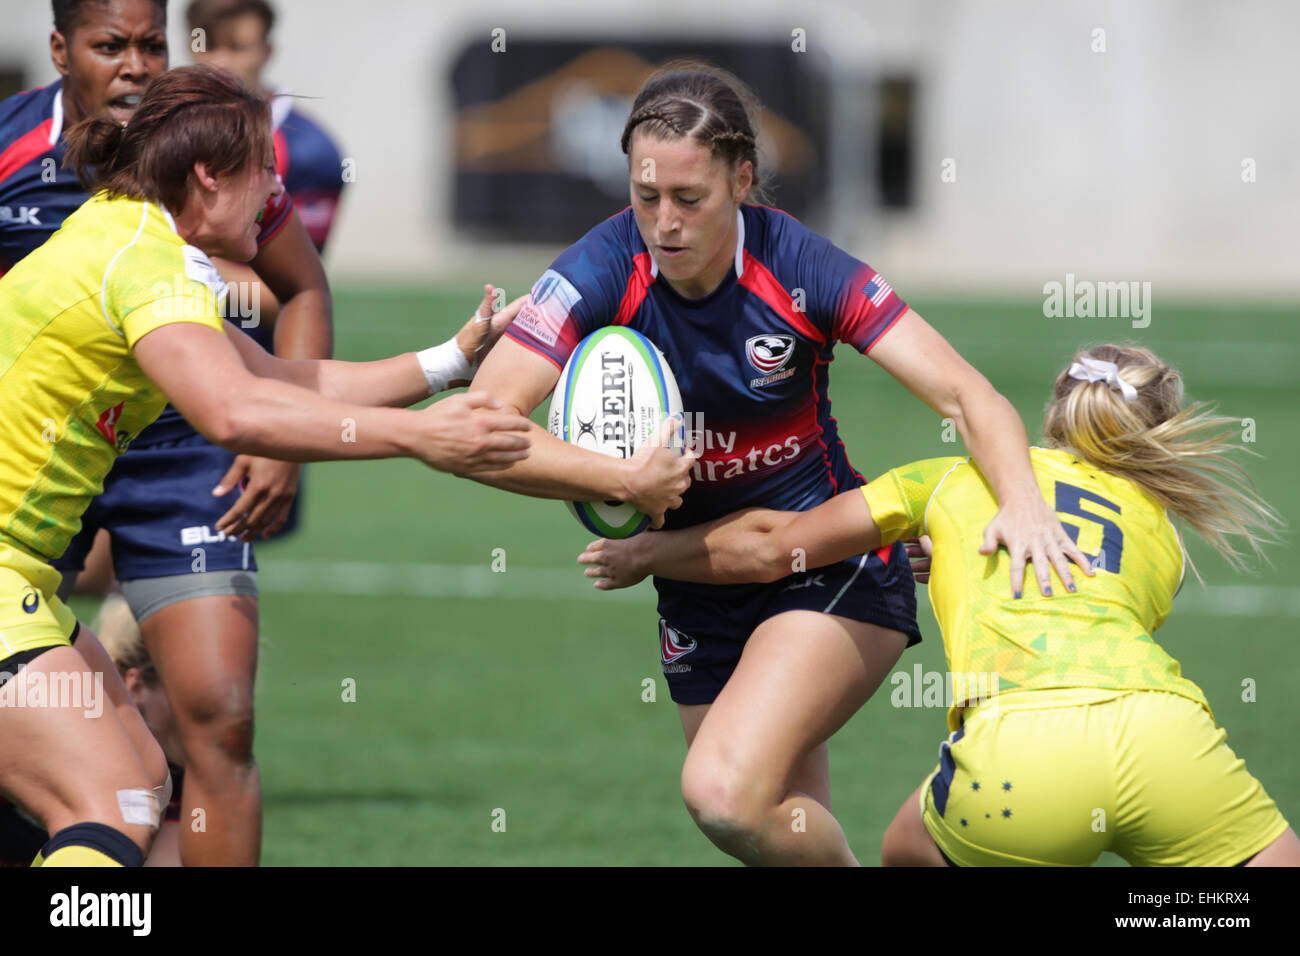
259 561 1300 622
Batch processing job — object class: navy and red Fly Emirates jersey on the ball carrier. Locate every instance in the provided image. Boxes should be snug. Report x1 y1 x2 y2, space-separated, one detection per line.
507 206 907 528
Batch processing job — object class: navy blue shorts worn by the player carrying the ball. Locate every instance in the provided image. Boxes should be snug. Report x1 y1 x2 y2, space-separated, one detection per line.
655 541 920 704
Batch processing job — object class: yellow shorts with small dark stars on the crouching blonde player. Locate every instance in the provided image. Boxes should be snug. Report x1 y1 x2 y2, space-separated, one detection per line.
920 688 1287 866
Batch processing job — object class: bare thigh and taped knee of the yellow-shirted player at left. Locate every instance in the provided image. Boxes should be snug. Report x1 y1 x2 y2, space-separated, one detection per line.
0 646 165 853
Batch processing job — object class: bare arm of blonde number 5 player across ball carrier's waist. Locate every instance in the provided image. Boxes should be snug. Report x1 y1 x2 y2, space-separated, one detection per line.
579 489 880 591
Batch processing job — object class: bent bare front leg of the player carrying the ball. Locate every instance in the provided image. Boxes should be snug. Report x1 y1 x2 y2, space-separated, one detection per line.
681 610 907 866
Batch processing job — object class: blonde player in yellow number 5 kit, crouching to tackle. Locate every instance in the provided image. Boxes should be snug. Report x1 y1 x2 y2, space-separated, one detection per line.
579 346 1300 866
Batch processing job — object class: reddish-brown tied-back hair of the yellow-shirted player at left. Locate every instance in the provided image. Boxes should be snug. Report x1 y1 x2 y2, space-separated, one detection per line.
64 66 274 212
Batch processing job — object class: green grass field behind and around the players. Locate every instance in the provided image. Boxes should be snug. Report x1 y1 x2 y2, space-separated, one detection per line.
83 285 1300 865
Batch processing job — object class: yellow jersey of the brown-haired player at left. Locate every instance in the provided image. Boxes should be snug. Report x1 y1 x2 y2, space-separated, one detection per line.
0 194 225 591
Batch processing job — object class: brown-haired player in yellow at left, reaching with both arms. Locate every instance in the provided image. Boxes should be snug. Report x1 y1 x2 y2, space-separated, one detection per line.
0 66 528 865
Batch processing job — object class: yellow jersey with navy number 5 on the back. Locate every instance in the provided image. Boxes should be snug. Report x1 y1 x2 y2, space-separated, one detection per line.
862 449 1209 730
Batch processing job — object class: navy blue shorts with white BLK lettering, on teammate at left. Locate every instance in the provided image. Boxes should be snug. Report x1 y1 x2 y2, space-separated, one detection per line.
52 433 257 581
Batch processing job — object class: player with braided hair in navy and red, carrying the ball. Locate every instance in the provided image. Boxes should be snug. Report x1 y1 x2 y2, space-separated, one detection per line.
475 65 1086 864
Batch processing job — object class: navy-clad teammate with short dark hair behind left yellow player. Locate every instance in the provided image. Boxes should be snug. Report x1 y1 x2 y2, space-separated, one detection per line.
0 0 340 865
